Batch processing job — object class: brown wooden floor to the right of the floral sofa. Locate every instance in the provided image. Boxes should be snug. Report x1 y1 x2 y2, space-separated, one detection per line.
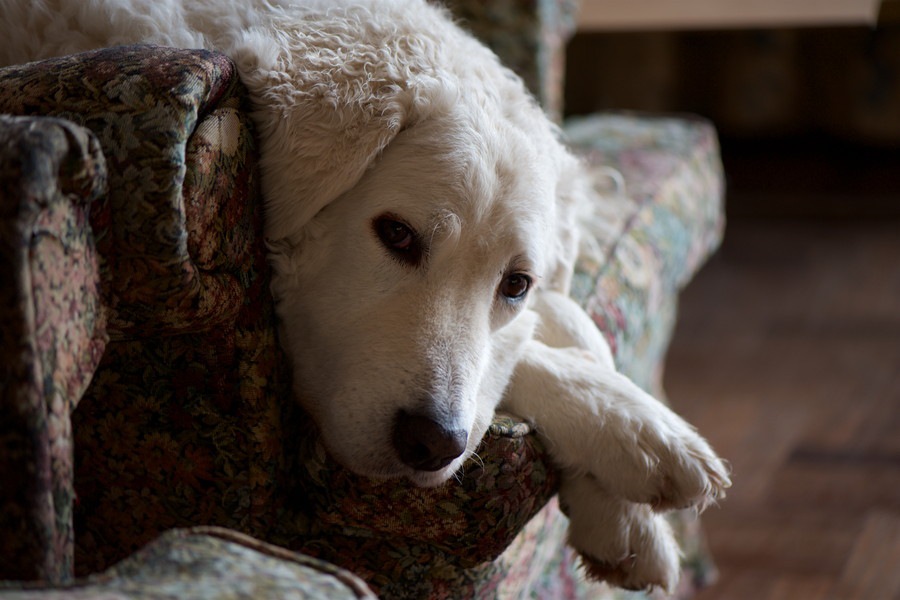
665 219 900 600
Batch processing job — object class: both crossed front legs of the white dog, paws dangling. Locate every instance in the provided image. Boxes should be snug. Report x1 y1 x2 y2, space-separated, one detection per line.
504 292 731 589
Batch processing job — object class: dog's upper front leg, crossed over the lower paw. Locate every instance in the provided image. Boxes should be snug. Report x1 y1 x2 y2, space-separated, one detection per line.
504 292 731 510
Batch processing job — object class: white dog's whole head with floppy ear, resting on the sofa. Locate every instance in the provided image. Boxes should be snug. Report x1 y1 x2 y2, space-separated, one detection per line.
237 3 592 485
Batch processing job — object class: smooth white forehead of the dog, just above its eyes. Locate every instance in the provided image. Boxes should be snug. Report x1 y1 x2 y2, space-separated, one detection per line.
370 118 558 271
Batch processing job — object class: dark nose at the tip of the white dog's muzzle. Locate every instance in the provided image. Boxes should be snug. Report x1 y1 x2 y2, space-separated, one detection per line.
394 410 469 471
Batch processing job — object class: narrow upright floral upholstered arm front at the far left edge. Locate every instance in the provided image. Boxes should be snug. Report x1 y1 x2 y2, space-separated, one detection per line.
0 116 106 581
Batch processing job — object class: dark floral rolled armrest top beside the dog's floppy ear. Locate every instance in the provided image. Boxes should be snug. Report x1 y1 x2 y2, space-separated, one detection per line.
0 47 255 336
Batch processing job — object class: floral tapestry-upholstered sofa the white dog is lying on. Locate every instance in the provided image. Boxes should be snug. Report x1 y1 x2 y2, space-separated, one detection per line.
0 3 723 598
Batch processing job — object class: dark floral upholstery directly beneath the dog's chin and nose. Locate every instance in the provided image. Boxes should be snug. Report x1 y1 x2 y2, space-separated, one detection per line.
270 415 562 599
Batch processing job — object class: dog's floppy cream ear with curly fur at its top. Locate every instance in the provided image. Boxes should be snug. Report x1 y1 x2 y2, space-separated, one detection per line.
232 4 455 244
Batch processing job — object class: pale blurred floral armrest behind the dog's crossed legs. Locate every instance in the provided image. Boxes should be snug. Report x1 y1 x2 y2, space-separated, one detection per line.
565 113 725 397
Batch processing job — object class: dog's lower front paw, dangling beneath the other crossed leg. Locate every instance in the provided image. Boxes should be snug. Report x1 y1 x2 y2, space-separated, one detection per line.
560 475 680 592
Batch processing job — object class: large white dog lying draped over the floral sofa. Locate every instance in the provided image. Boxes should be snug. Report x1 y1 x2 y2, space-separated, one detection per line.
0 0 730 589
